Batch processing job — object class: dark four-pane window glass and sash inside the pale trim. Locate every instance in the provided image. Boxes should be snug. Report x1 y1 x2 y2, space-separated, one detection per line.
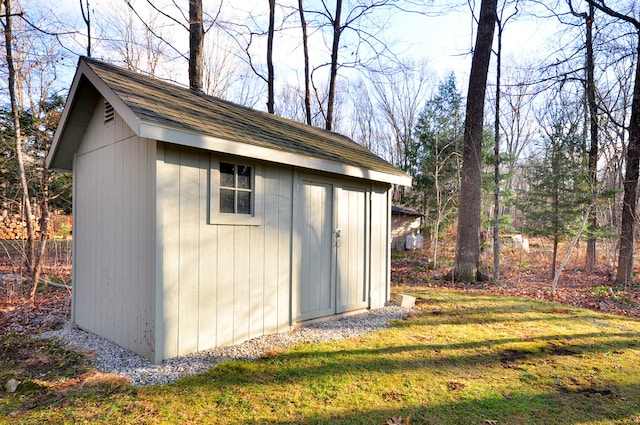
220 162 253 214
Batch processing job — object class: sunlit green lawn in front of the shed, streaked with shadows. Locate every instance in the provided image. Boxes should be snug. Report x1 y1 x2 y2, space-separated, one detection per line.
0 289 640 425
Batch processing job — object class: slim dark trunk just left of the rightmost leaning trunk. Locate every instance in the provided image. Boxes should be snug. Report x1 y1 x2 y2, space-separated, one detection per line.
585 5 599 272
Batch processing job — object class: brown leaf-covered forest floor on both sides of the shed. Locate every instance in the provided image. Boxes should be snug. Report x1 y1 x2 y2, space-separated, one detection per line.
0 238 640 334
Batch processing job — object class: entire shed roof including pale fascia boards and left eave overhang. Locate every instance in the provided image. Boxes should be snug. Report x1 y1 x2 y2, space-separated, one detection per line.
47 57 411 185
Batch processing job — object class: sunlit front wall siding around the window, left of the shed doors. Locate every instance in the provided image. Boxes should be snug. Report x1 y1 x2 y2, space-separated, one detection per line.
156 144 293 360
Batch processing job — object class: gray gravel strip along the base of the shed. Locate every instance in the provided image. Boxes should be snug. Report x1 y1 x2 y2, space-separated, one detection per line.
38 306 409 386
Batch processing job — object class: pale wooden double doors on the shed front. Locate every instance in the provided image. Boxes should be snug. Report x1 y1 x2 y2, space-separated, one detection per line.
292 176 369 321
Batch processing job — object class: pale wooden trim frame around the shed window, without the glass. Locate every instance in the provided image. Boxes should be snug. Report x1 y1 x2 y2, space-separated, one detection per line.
209 155 264 226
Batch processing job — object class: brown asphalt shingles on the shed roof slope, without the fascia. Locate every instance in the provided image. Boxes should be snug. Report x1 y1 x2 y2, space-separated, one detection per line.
81 58 406 176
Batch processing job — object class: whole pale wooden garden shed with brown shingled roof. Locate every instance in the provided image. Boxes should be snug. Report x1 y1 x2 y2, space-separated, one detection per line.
47 58 411 362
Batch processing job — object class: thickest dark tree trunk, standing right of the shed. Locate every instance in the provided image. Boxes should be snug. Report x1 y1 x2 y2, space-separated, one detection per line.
453 0 497 282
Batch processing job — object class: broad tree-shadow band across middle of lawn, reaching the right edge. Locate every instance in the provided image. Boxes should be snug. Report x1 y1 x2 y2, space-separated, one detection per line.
194 333 640 385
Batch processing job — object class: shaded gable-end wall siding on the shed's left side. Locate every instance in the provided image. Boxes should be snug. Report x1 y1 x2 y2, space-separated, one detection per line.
73 101 156 357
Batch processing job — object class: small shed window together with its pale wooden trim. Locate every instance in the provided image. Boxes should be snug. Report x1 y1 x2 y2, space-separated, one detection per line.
208 155 264 226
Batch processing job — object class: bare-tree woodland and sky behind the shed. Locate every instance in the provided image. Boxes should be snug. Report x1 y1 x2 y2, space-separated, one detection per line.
0 0 640 283
